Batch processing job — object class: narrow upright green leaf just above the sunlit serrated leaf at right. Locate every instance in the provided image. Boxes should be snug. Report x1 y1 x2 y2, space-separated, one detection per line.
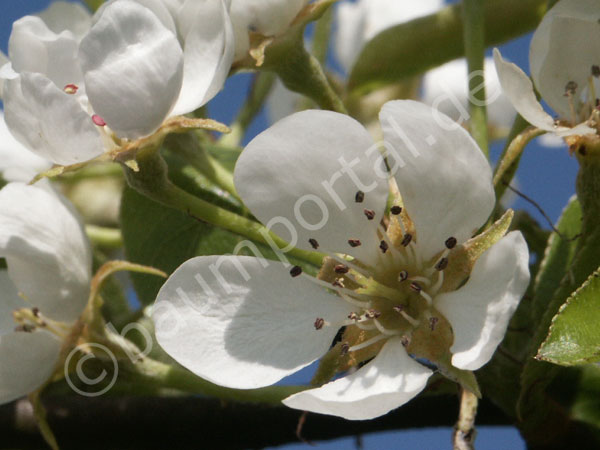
532 196 582 318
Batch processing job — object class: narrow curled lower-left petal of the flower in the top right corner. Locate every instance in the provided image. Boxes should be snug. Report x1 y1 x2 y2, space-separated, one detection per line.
494 48 594 134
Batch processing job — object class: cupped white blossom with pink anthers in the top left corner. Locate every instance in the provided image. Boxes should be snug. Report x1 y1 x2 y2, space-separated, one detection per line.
1 0 234 164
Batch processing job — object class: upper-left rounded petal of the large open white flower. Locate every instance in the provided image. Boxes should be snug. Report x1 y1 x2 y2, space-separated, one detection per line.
234 110 388 264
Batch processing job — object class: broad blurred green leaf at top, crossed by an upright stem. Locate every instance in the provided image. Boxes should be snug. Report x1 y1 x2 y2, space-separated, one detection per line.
348 0 547 94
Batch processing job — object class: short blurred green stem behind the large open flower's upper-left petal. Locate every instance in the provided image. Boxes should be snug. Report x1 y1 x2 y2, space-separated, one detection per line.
219 72 275 147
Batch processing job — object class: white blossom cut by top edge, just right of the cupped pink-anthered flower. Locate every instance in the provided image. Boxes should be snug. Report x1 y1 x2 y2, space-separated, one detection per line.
230 0 309 61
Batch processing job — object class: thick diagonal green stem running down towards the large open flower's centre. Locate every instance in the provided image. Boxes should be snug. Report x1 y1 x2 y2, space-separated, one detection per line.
124 148 323 267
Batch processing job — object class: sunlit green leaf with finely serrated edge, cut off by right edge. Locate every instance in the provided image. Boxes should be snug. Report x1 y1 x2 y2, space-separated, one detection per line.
537 269 600 366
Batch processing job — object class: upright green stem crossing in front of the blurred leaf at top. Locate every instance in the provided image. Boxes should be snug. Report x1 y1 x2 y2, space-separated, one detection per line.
463 0 490 158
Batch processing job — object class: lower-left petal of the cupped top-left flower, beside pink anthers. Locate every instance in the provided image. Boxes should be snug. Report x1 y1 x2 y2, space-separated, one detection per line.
4 73 104 165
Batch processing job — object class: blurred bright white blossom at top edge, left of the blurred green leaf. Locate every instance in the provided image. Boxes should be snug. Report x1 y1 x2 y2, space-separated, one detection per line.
335 0 444 71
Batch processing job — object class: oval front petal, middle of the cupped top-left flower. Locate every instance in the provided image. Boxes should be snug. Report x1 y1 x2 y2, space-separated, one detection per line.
79 1 183 139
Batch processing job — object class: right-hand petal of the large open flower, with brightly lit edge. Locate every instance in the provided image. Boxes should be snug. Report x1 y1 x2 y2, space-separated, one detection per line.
435 231 529 370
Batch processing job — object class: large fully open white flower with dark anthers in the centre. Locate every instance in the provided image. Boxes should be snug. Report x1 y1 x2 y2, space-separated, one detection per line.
153 101 529 419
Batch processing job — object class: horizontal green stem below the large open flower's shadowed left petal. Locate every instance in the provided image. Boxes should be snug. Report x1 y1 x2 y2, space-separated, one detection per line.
129 358 307 404
